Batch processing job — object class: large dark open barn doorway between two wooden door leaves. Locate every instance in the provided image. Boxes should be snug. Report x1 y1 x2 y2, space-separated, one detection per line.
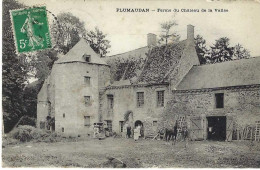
207 116 226 141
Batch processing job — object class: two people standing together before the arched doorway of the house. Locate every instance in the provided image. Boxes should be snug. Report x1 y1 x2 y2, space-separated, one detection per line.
123 123 143 141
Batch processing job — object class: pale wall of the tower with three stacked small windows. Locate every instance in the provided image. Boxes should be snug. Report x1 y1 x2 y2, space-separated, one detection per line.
53 63 109 135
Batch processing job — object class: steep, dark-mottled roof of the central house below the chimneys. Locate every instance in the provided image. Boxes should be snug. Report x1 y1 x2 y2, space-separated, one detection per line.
107 40 186 86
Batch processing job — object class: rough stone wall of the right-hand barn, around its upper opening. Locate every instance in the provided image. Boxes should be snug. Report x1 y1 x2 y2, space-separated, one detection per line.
164 87 260 134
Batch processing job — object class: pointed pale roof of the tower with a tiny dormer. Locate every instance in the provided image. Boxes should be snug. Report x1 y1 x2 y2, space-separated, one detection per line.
55 39 107 65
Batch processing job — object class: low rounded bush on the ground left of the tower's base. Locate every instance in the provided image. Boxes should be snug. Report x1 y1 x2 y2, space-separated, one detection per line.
9 125 62 142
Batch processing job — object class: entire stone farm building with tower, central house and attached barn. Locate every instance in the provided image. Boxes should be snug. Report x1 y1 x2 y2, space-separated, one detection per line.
37 25 260 141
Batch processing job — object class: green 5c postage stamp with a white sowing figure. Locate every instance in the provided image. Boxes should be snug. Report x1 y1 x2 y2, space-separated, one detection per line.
10 7 51 53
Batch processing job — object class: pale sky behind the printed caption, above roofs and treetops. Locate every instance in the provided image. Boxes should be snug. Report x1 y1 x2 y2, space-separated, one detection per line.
19 0 260 57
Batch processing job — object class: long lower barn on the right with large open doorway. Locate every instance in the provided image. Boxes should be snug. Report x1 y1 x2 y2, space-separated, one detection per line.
165 57 260 141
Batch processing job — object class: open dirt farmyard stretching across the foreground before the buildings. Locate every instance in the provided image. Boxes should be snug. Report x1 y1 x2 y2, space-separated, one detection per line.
2 138 260 168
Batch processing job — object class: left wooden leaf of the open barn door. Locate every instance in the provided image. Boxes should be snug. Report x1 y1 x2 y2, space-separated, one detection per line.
190 116 204 140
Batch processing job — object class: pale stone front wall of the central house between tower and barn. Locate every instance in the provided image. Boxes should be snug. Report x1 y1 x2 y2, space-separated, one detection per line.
100 85 169 136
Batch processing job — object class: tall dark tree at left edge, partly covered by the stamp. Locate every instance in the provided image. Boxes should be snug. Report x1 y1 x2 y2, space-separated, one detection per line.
2 0 28 132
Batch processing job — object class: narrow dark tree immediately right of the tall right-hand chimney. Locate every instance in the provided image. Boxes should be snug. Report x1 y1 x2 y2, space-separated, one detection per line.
194 35 209 64
